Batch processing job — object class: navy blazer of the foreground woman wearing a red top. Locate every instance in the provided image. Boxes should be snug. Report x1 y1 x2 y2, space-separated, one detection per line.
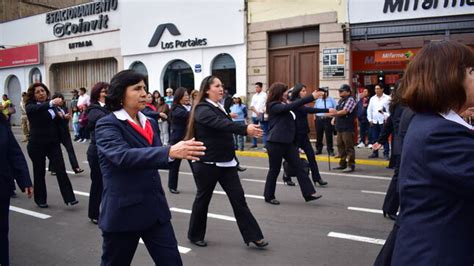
95 113 171 232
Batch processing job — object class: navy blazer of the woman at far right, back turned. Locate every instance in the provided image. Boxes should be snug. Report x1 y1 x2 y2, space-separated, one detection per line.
392 114 474 266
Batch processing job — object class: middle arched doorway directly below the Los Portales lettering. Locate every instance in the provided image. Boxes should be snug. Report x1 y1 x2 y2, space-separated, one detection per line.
163 59 194 91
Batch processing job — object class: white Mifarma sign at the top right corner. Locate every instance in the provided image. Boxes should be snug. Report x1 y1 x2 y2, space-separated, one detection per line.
348 0 474 24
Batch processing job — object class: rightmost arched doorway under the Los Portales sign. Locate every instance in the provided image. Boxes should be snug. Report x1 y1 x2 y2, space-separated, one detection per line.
212 54 237 95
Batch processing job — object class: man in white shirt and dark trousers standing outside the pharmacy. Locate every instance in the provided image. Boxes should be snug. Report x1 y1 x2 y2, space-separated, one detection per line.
367 85 391 160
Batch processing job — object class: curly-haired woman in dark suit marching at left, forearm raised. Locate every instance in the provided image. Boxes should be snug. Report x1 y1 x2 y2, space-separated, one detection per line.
26 83 78 208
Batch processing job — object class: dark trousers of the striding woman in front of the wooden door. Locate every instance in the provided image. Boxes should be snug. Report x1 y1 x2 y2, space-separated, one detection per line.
263 141 316 201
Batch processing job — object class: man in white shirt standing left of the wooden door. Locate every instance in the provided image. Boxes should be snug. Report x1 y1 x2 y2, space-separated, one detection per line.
249 82 268 149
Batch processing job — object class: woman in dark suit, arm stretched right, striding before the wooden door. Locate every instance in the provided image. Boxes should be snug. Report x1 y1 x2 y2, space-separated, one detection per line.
264 82 323 205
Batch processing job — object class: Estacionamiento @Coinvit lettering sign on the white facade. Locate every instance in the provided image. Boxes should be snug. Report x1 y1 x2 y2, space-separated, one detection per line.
46 0 118 38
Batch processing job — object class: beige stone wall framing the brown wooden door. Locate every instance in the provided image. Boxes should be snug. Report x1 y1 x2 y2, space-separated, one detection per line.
247 0 351 99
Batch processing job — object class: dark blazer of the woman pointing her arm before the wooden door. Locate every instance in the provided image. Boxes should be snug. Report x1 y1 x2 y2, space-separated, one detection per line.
267 95 314 143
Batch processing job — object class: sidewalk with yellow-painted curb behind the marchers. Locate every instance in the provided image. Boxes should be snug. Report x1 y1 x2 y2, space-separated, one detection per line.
236 140 389 167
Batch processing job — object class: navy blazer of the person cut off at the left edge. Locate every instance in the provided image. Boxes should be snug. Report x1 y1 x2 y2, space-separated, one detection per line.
0 115 32 199
